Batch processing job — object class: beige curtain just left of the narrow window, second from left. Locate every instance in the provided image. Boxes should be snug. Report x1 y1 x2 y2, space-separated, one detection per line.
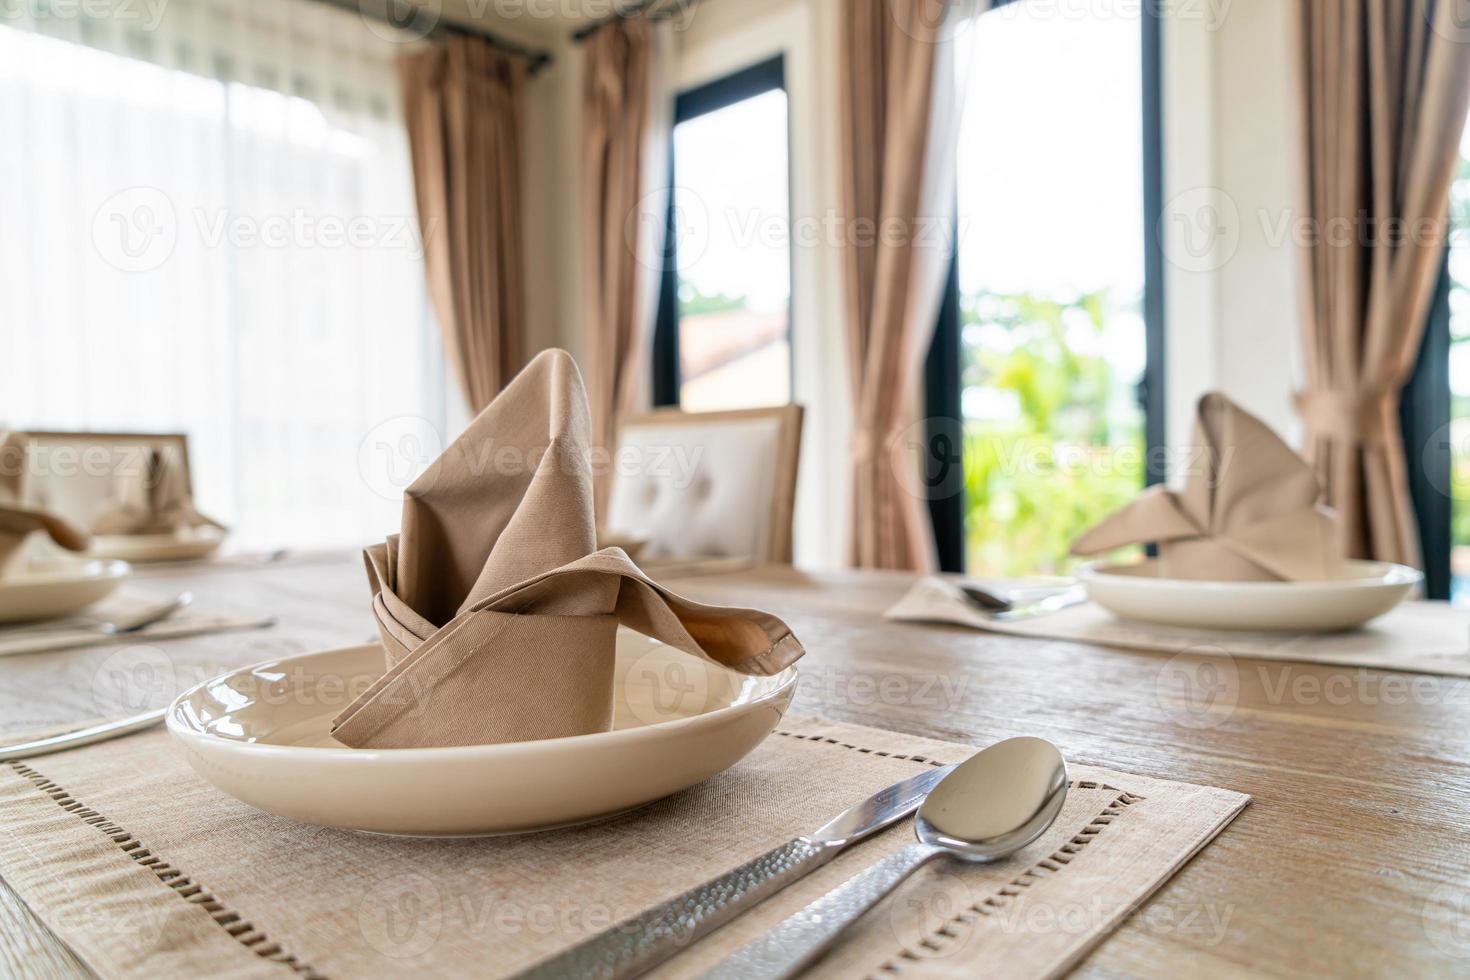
581 18 672 519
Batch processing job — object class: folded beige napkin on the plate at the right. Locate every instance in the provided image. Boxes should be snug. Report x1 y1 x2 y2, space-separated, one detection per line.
1072 392 1342 582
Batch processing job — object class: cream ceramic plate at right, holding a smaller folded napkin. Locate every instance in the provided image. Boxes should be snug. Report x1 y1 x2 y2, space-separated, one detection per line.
1078 560 1423 633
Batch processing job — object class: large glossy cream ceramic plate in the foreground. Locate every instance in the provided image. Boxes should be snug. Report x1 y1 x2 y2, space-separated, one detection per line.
168 629 797 836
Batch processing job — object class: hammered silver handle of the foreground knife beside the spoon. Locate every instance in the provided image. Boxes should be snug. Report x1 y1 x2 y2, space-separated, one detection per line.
516 837 839 980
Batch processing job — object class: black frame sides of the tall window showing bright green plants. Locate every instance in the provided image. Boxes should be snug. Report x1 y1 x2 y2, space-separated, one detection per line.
925 0 1167 572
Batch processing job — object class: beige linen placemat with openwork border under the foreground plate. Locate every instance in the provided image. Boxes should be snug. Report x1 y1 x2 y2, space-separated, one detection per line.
0 718 1247 979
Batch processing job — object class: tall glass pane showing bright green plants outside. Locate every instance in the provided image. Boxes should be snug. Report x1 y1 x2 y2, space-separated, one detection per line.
960 3 1145 574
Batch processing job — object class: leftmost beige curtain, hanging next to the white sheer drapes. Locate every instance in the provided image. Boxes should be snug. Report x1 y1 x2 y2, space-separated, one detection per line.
398 34 526 414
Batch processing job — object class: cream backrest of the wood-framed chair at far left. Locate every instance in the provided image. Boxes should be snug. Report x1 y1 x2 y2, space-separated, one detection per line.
21 432 193 527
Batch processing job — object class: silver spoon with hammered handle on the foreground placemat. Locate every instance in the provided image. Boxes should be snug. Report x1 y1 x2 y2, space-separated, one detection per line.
704 738 1067 980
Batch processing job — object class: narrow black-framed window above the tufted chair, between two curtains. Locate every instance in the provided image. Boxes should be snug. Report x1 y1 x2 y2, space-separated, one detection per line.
654 59 791 411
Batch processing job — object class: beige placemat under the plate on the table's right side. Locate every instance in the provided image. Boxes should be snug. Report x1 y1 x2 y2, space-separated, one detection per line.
883 579 1470 677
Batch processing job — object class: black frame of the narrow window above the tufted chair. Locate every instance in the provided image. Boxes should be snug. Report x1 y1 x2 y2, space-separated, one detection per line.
653 54 795 407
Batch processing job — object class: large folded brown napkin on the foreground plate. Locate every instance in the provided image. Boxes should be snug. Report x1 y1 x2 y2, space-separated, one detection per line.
332 350 803 748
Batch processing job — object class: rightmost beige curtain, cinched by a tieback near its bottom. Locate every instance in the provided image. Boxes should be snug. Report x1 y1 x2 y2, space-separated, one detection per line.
1294 0 1470 564
